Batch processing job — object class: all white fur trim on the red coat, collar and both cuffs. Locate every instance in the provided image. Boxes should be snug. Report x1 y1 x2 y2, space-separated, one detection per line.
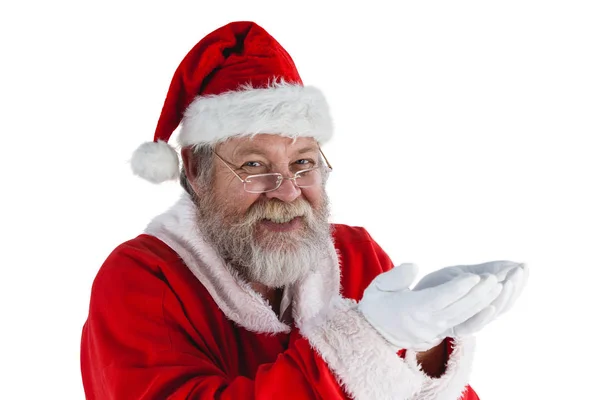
145 193 473 400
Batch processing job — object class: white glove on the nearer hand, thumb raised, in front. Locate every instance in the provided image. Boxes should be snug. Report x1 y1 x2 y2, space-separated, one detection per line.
358 264 502 351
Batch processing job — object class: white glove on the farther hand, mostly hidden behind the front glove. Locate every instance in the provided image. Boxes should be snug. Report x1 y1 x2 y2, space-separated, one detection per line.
413 261 529 337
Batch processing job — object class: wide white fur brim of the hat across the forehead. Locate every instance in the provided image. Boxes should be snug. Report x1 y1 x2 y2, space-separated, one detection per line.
178 82 333 146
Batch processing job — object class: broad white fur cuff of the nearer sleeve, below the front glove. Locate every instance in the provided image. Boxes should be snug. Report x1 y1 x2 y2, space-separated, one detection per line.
300 296 425 400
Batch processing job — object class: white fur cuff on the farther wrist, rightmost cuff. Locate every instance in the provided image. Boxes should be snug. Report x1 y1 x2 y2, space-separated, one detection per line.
405 337 475 400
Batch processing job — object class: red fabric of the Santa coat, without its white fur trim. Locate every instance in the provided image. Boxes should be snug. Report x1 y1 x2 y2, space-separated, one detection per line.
81 225 478 400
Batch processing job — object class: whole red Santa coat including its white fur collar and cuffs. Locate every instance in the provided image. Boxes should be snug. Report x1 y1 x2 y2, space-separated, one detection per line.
81 197 478 400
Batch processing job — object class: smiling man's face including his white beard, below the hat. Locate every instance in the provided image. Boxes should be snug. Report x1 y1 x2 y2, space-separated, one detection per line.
197 135 331 287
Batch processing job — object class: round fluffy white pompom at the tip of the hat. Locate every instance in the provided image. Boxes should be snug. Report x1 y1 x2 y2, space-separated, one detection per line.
131 140 179 183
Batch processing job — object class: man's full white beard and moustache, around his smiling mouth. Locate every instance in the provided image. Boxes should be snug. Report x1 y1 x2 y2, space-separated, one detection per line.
197 188 332 288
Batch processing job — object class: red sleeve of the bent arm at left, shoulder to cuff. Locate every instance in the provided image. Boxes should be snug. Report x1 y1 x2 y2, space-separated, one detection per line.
81 245 346 400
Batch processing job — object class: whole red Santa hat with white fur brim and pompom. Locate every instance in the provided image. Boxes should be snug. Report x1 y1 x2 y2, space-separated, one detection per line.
131 22 333 183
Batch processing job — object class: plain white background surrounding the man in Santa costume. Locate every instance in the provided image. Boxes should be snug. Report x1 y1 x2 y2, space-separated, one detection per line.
0 0 600 400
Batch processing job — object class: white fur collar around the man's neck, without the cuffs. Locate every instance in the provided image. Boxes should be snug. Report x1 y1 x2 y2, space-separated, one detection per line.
145 193 340 333
